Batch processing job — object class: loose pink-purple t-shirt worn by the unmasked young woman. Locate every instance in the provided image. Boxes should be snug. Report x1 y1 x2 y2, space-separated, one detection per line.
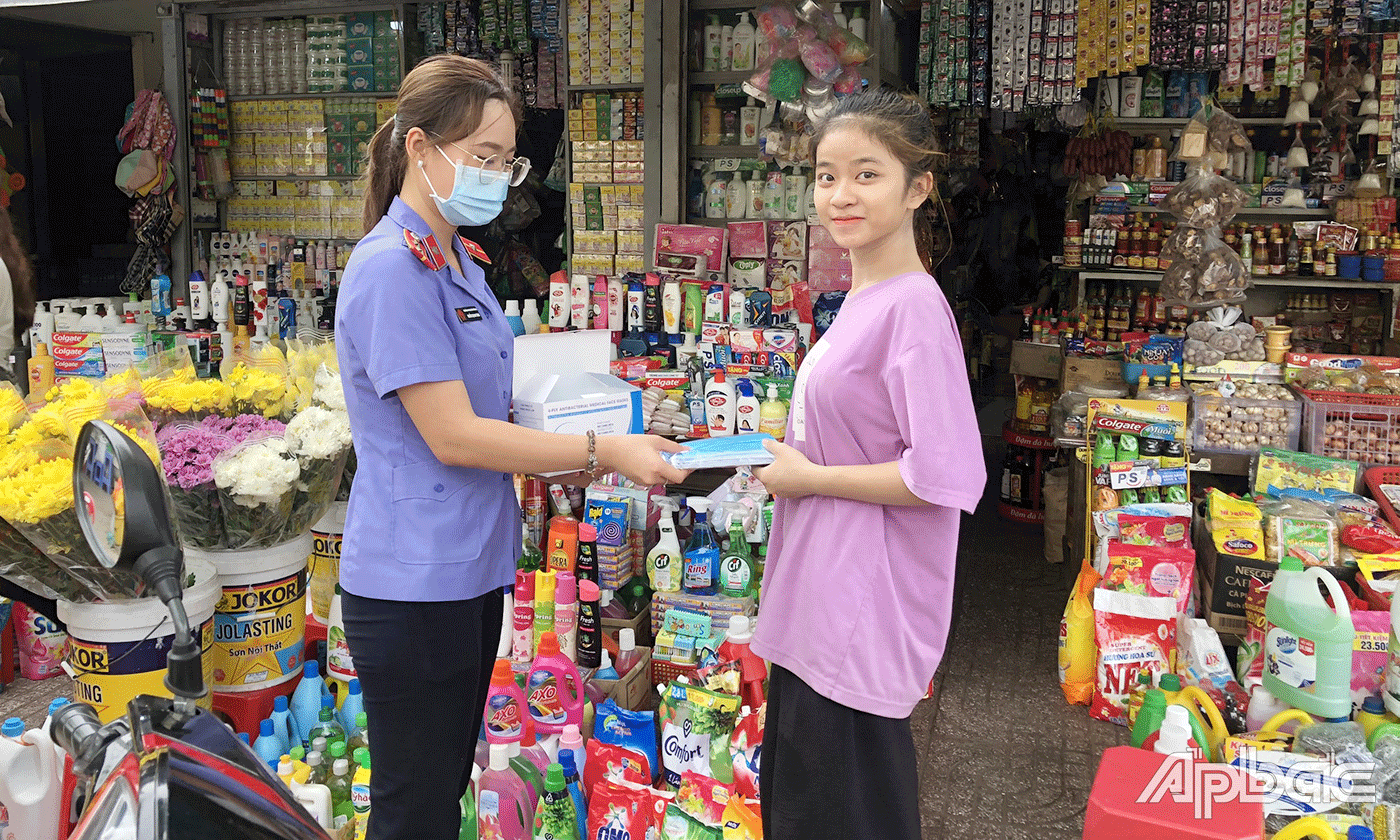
753 274 987 718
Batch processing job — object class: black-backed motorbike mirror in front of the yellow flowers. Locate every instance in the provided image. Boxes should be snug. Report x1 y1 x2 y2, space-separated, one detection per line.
73 420 179 571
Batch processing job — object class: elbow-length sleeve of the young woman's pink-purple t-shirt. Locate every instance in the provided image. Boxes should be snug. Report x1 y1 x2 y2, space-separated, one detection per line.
885 292 986 514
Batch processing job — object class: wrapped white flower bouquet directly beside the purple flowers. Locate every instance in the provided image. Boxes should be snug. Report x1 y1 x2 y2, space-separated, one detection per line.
214 435 301 549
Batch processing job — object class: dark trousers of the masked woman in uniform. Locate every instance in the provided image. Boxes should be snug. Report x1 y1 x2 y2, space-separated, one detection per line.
342 591 503 840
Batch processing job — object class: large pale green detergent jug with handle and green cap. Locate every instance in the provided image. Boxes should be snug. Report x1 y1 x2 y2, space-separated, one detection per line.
1264 557 1357 718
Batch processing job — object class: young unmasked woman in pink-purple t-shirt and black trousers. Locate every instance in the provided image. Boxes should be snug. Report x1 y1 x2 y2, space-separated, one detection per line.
753 92 987 840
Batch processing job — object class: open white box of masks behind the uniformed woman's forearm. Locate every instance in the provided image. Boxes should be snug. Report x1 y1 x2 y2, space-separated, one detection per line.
512 329 643 434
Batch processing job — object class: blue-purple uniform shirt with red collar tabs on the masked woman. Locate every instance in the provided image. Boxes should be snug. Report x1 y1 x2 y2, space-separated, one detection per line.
336 197 521 601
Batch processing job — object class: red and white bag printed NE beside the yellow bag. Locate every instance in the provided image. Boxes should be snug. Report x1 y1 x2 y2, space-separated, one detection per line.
1089 588 1176 727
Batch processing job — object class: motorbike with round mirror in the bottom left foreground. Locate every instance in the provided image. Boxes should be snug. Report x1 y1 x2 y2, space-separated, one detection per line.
38 420 329 840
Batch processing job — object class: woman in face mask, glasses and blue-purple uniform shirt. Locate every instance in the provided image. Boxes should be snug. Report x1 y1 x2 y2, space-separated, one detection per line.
336 55 685 840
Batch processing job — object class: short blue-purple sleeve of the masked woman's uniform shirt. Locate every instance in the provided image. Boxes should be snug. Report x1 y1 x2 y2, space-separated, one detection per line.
340 249 462 399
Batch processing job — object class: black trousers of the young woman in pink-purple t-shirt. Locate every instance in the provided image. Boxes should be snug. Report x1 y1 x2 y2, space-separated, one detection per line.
759 665 921 840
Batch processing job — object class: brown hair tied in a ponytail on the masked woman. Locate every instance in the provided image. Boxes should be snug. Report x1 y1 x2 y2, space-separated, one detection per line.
361 55 521 234
